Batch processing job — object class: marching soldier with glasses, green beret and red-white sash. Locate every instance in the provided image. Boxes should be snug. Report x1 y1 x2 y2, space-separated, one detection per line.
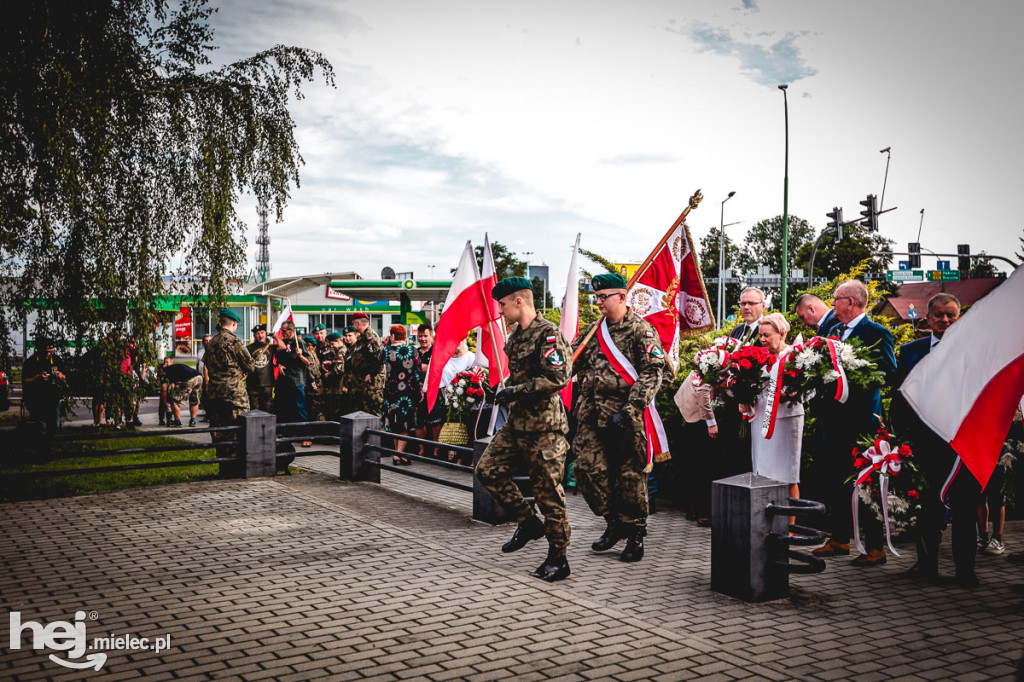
572 274 667 561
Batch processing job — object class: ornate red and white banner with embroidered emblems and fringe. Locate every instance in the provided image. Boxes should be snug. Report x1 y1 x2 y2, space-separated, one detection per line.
626 220 715 373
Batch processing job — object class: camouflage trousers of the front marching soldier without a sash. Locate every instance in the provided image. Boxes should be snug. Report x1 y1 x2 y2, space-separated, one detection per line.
476 428 569 556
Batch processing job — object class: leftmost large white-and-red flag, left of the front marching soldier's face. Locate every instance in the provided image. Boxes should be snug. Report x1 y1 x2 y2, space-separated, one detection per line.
426 242 493 411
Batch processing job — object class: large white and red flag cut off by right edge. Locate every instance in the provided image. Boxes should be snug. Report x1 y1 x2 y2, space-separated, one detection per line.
900 266 1024 487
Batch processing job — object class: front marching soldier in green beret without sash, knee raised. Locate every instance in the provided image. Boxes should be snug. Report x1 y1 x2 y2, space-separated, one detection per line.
476 278 572 583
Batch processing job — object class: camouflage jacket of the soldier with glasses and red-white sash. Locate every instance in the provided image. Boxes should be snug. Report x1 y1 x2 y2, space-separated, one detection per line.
572 309 668 426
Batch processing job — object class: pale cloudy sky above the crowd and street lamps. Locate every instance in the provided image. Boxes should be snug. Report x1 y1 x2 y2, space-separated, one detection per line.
207 0 1024 296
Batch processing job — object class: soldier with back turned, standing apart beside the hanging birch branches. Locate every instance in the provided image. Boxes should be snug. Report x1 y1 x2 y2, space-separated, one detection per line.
203 308 253 457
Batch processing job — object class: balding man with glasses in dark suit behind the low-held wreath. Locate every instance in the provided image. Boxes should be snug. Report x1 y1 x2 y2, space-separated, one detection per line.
814 280 896 566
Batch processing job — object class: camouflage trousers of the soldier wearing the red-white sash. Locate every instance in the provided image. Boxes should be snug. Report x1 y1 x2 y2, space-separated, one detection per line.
572 422 647 528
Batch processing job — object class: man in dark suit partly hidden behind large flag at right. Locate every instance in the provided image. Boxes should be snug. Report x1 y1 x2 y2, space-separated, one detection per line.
890 294 981 587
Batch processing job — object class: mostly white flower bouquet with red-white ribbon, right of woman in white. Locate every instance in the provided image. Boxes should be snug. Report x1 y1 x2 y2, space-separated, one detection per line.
782 336 885 402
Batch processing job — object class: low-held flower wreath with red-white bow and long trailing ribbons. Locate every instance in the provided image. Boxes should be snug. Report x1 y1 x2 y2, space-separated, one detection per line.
851 429 921 556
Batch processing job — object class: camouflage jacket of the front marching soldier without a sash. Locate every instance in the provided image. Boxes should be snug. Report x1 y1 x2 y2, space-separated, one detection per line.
505 315 572 433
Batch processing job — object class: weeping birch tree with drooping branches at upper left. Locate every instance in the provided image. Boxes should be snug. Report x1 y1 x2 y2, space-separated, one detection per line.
0 0 334 372
